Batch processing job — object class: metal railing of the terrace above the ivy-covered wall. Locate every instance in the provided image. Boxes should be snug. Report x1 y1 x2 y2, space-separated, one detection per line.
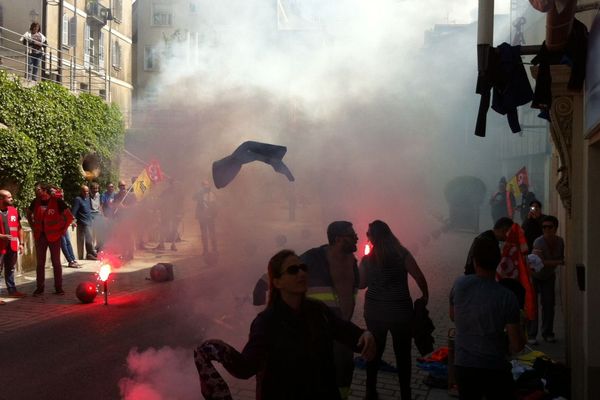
0 26 109 100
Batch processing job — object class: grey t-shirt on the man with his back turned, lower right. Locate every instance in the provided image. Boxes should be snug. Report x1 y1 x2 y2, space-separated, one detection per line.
450 275 519 369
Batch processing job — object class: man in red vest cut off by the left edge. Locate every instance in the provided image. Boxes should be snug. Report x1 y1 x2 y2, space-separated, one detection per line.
0 190 25 305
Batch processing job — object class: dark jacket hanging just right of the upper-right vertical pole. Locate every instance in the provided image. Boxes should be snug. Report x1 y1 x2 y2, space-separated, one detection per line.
492 43 533 133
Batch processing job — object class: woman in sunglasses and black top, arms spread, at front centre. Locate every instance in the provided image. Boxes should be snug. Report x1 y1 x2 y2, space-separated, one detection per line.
196 250 375 400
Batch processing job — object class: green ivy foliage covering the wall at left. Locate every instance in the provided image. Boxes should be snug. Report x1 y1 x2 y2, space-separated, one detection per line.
0 71 125 207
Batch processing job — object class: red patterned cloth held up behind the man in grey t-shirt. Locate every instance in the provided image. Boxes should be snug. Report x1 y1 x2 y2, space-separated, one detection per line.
496 224 537 320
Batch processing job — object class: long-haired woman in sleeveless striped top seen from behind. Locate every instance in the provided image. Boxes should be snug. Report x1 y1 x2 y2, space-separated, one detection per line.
359 220 429 400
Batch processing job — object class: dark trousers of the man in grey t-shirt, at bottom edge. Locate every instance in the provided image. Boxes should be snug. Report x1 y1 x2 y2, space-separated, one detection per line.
454 364 516 400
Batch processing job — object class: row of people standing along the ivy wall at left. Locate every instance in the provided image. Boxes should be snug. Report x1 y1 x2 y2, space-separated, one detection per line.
0 181 186 304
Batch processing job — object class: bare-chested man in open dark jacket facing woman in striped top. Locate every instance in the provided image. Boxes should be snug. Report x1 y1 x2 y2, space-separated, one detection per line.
300 221 358 399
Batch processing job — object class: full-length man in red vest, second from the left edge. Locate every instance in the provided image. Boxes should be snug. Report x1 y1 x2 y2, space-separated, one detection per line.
27 183 73 296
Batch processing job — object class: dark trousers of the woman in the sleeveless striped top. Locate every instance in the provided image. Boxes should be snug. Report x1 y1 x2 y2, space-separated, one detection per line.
365 318 412 399
